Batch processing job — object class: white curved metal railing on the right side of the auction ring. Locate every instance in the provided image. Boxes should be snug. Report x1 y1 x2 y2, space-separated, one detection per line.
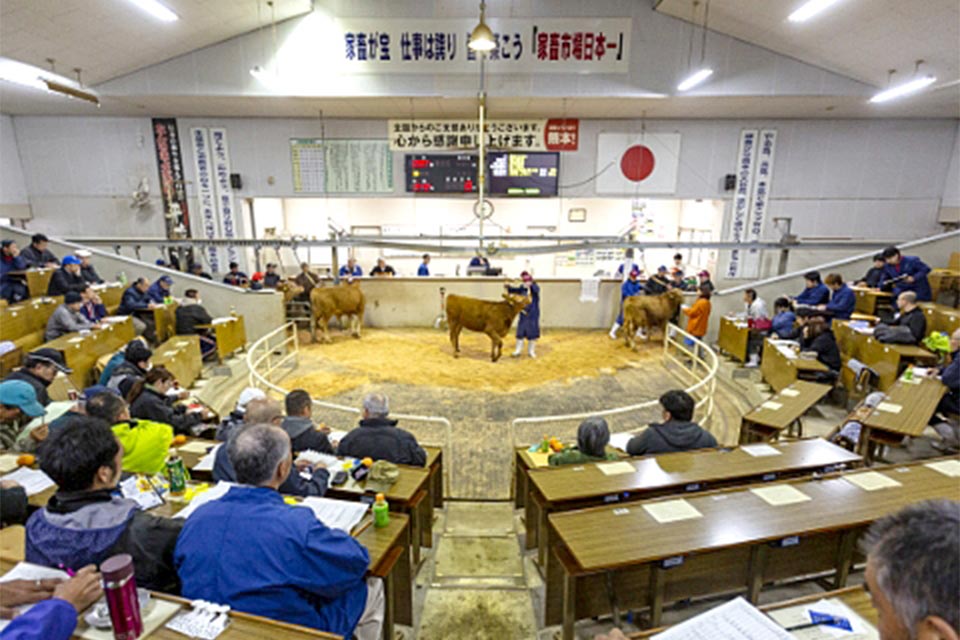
511 324 720 448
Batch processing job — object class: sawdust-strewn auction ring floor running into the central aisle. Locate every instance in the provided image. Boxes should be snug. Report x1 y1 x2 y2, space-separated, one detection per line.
280 329 686 500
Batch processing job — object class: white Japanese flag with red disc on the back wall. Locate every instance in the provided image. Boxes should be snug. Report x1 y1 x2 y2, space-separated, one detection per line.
597 133 680 195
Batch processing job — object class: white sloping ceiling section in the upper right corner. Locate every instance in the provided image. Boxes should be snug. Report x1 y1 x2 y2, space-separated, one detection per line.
656 0 960 87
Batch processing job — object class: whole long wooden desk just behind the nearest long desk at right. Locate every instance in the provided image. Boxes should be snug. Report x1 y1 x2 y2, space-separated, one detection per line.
526 438 862 569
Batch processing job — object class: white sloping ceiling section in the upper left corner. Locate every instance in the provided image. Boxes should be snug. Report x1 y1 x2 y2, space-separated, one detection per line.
0 0 311 85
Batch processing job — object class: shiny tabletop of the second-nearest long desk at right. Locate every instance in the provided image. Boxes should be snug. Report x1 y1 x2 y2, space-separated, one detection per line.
530 438 861 503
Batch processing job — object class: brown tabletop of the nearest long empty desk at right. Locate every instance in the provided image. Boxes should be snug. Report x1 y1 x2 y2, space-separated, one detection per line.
549 462 958 573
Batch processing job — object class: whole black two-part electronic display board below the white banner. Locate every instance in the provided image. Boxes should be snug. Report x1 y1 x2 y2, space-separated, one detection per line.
404 151 560 197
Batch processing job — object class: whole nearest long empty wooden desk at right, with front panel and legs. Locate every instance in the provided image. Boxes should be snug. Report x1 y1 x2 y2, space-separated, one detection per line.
545 457 957 640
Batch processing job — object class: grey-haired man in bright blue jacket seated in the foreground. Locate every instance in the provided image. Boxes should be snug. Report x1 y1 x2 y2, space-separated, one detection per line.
174 424 384 640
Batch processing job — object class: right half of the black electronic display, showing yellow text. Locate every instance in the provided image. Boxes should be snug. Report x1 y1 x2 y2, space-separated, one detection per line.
487 151 560 197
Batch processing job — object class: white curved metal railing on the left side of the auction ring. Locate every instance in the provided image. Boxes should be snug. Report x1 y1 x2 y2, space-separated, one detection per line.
247 322 453 497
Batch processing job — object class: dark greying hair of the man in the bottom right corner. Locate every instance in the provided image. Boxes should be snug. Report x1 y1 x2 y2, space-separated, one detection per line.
862 500 960 638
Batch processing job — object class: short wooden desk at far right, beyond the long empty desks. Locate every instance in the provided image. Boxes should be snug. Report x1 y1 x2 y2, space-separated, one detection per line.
857 378 947 464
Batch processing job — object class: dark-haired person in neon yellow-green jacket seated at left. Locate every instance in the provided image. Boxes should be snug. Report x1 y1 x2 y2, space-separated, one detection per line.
84 391 173 474
